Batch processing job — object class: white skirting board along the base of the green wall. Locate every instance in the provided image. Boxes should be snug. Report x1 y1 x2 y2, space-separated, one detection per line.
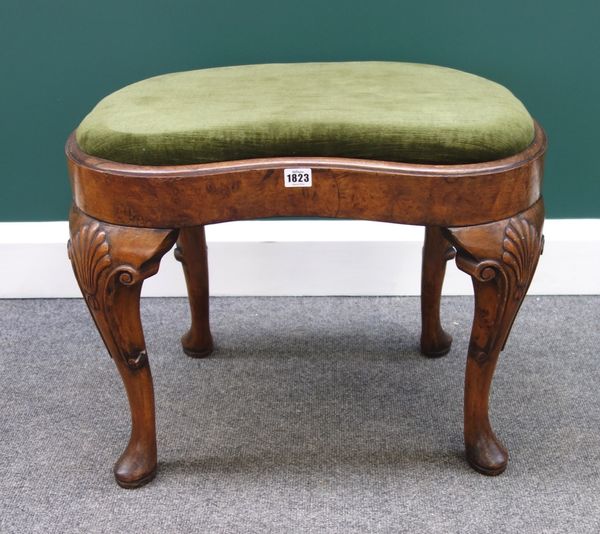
0 219 600 298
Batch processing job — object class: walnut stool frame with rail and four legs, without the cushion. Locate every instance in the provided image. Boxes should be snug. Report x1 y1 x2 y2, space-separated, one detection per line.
66 124 546 488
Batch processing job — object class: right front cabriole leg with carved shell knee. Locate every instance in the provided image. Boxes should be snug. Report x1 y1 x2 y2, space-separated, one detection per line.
447 199 544 475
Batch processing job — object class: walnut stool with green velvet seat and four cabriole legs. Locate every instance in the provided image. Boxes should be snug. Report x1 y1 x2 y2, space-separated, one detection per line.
67 62 546 487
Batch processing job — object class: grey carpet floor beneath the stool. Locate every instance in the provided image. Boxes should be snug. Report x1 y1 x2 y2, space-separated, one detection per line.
0 297 600 534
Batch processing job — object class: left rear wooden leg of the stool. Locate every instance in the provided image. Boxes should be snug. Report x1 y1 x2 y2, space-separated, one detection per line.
175 226 213 358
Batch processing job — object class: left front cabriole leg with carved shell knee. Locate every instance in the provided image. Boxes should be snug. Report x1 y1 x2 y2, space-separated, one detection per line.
69 208 177 488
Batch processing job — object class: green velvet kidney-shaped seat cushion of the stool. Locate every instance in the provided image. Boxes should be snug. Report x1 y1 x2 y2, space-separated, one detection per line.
77 62 534 165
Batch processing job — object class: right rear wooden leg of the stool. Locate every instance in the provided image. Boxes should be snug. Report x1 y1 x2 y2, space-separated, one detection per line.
421 226 455 358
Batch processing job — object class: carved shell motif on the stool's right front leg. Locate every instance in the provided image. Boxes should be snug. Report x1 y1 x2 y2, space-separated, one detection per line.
502 217 540 300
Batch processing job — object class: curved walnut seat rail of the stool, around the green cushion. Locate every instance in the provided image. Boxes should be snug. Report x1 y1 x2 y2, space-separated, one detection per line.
66 123 546 228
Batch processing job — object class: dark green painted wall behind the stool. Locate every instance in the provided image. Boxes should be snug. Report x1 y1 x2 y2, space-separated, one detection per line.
0 0 600 221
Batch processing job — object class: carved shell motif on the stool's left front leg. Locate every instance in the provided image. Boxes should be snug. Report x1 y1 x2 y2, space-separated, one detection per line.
68 222 112 310
